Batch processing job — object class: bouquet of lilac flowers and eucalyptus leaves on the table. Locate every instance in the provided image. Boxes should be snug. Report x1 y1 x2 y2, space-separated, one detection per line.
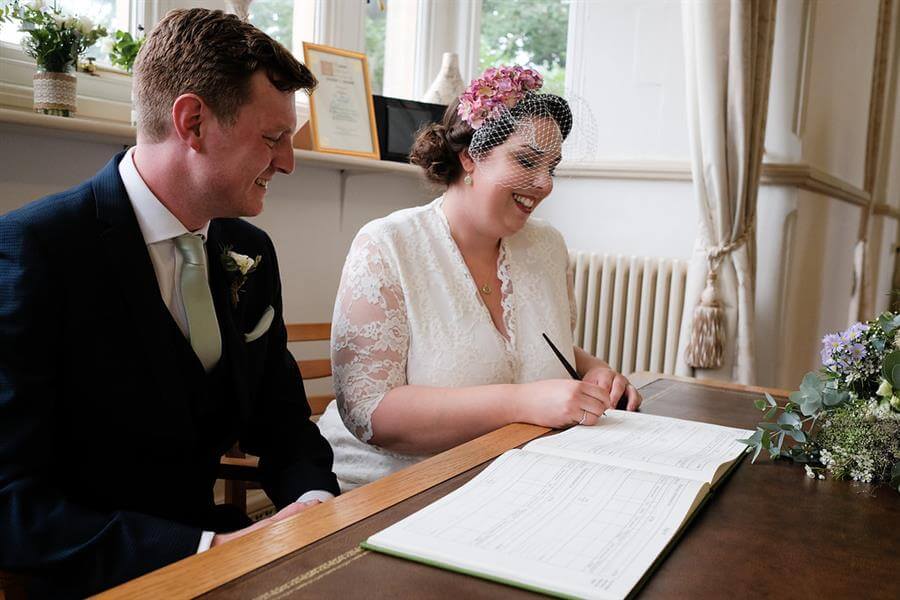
740 313 900 491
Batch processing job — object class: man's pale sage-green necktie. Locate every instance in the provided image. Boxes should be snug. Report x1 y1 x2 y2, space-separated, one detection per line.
175 233 222 373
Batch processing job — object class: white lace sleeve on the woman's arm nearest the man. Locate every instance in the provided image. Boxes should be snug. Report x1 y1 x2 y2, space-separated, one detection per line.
331 233 409 442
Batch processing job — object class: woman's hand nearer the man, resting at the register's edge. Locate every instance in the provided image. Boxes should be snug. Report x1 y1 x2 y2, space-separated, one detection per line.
516 379 610 429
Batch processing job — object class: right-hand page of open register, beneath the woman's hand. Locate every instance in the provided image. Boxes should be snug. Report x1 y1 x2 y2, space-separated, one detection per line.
525 410 753 482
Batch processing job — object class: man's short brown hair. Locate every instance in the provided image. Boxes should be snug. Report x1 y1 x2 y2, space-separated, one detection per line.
134 8 317 142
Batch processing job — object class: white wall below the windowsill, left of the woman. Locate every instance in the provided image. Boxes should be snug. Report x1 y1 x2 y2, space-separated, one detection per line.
0 126 433 321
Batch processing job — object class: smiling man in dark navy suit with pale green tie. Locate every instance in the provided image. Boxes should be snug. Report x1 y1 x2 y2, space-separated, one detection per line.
0 9 338 596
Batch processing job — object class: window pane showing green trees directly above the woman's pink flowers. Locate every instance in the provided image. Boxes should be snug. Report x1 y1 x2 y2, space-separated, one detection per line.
480 0 569 95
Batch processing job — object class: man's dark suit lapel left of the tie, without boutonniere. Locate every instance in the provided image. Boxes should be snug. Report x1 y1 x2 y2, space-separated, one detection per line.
92 153 190 436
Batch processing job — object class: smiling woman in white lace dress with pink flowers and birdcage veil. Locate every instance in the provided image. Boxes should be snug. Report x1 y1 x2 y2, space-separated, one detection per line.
319 67 641 491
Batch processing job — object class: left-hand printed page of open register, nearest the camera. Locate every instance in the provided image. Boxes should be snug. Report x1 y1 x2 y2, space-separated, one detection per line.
368 450 704 598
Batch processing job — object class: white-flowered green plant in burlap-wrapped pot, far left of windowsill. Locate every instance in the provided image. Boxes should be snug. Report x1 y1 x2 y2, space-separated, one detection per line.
0 0 106 117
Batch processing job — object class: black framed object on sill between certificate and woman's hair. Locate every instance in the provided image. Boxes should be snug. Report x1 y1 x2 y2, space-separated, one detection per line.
372 94 447 163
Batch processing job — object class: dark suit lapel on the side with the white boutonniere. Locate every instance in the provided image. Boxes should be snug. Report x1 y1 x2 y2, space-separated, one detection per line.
206 219 250 420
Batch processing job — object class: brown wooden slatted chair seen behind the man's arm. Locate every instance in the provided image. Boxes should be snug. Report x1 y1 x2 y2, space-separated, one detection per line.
219 323 334 513
